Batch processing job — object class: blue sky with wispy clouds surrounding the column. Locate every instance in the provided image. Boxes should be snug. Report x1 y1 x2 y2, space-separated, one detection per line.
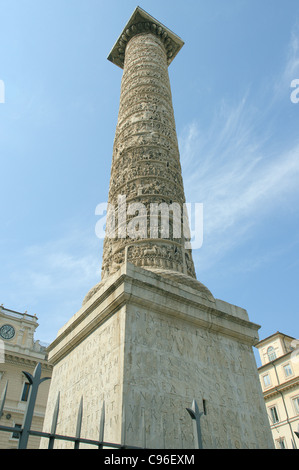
0 0 299 368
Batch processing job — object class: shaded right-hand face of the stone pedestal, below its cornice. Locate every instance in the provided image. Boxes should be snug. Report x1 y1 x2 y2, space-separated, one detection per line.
124 309 274 448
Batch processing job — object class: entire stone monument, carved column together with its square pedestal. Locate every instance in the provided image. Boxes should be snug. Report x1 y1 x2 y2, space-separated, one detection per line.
42 7 273 449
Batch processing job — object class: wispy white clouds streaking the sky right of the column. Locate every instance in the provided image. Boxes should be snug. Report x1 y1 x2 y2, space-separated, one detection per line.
179 24 299 276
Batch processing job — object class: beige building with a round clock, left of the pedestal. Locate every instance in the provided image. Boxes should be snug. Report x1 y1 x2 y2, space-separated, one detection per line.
0 306 52 449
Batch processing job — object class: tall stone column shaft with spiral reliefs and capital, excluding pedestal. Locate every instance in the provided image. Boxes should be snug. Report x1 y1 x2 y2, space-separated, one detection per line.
102 13 195 279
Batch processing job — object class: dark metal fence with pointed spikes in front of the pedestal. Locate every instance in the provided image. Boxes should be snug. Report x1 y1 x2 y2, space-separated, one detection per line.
0 363 204 449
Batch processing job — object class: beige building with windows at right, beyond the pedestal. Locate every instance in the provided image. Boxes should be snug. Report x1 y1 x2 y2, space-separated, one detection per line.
256 331 299 449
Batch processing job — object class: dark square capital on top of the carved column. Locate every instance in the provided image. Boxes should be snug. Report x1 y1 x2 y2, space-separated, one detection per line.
108 7 184 68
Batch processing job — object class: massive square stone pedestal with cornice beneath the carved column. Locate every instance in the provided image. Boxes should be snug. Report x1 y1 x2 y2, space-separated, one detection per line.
43 263 273 449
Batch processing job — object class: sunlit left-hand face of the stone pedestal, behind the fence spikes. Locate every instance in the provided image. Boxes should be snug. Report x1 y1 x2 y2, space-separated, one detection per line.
44 310 124 448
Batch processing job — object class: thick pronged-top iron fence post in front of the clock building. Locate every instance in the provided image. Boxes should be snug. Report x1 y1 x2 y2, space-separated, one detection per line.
18 362 50 449
